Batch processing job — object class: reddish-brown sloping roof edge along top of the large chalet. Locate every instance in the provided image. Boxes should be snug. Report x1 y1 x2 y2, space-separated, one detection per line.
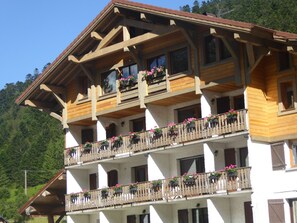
16 0 297 104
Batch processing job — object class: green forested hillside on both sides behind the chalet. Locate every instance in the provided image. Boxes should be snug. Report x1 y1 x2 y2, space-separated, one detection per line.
0 0 297 222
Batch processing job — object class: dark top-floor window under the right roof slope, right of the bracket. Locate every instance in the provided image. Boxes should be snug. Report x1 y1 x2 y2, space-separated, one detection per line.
204 35 231 64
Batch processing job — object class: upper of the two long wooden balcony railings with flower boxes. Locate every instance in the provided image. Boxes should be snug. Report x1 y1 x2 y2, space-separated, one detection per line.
64 110 247 166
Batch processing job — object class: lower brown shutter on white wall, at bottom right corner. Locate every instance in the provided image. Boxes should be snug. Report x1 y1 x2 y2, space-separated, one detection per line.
268 199 285 223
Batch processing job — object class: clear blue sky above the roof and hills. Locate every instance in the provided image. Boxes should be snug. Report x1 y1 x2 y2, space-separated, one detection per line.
0 0 194 89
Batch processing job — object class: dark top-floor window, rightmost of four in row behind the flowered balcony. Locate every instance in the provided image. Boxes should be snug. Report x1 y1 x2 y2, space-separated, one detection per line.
170 47 189 74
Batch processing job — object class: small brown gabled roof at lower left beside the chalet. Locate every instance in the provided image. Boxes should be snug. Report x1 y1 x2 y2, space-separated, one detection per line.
18 169 66 215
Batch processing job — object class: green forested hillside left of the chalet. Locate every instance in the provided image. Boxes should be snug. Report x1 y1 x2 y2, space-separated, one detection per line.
0 69 64 222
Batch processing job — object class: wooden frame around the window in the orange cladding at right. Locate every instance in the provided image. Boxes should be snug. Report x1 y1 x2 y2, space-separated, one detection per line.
277 75 297 115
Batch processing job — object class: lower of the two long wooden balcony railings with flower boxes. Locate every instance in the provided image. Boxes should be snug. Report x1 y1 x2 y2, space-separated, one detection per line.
65 168 251 211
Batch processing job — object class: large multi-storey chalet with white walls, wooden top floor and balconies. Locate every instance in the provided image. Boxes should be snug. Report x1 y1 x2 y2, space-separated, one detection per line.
17 0 297 223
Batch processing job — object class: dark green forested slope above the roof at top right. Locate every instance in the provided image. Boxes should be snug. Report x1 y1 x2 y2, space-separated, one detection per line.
180 0 297 33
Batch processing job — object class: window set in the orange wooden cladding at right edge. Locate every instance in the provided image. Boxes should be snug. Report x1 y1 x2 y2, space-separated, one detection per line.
278 77 297 112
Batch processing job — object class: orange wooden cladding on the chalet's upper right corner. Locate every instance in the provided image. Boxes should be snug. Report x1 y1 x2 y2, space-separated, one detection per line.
247 53 297 142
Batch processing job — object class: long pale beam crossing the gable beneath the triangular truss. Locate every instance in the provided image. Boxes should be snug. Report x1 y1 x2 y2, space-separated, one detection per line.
79 27 177 63
